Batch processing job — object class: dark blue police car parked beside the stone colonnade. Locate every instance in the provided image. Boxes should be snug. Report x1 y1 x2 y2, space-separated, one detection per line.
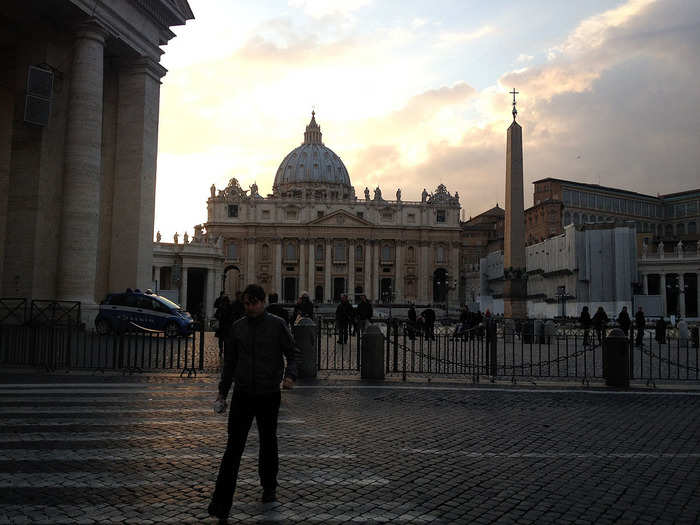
95 289 194 337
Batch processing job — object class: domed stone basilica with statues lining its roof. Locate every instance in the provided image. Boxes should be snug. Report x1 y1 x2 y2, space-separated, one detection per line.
154 114 461 314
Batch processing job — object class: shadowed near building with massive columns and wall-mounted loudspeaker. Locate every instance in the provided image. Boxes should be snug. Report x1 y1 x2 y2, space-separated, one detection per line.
0 0 193 322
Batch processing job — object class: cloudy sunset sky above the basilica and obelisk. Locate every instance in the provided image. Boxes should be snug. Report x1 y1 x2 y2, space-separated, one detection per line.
155 0 700 240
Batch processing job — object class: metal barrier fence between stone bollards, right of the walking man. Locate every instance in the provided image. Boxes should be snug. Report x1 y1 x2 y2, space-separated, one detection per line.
317 319 700 384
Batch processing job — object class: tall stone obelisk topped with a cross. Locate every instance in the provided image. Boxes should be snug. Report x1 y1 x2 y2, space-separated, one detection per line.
503 89 527 319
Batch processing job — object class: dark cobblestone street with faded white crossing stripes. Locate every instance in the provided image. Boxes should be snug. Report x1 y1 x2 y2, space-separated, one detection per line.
0 374 700 524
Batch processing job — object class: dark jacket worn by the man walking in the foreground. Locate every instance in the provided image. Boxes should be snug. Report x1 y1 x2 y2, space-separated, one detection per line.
219 312 298 397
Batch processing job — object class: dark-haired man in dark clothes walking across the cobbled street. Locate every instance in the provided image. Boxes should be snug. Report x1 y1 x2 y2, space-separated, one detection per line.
208 284 297 520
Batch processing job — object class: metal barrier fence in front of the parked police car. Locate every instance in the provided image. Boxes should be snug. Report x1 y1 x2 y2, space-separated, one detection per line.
0 325 204 377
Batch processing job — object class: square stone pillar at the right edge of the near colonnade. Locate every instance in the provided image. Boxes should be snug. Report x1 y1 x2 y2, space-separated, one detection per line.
109 57 166 290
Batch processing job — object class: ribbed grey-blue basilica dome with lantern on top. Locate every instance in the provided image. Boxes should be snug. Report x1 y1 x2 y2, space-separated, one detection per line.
272 112 354 197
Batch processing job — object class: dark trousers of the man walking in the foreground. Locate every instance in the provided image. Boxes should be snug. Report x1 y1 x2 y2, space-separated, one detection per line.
212 389 280 514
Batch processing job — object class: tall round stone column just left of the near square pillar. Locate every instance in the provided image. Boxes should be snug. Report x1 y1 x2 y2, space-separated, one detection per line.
56 23 107 304
